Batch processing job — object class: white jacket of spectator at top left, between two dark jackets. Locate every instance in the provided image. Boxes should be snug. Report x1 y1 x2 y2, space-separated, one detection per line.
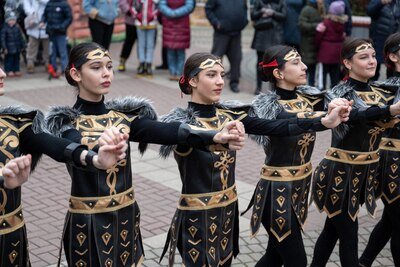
24 0 49 39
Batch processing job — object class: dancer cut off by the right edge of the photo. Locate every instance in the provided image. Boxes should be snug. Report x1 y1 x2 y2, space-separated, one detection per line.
360 33 400 267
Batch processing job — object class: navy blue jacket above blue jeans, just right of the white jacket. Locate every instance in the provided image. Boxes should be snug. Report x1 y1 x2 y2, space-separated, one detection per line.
42 0 72 36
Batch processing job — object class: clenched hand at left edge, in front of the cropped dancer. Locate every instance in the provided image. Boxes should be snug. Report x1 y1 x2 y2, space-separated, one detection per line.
2 154 32 189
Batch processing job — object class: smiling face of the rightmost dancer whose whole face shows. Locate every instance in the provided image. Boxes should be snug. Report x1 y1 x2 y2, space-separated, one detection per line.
343 48 377 82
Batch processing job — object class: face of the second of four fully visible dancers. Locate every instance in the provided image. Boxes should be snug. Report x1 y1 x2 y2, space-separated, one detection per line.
189 64 225 105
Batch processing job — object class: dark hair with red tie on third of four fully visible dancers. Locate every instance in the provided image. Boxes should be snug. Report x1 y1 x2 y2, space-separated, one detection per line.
257 45 295 84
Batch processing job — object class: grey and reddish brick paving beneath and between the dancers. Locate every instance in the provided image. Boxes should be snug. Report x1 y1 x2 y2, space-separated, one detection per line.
0 27 394 267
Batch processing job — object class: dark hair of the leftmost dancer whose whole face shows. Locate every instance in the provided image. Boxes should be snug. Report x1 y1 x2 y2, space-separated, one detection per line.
64 42 107 87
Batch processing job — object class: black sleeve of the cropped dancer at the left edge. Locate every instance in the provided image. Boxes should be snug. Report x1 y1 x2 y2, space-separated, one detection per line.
20 127 83 165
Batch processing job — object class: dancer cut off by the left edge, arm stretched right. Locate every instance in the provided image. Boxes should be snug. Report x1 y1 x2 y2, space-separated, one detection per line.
0 65 127 266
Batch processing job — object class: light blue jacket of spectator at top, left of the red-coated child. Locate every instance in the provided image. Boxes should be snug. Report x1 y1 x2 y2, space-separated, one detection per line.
82 0 119 25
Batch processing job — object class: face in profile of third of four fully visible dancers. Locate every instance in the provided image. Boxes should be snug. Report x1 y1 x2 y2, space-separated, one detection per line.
274 56 307 90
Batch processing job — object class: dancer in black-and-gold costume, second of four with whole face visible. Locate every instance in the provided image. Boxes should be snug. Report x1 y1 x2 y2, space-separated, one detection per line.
160 53 347 266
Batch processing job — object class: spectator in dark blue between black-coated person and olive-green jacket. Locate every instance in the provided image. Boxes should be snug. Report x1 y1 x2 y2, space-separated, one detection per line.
283 0 306 52
